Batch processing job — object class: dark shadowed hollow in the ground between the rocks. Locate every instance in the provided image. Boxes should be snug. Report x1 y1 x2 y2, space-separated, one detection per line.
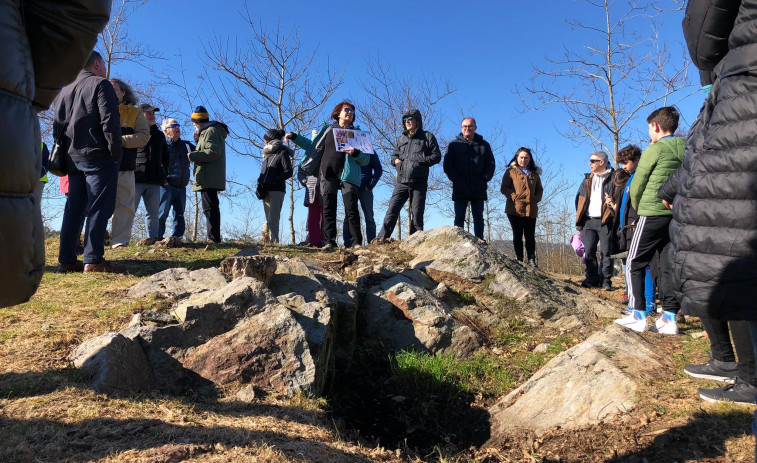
329 348 490 461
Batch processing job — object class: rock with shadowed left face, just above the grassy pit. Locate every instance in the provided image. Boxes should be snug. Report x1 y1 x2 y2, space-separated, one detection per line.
360 272 479 355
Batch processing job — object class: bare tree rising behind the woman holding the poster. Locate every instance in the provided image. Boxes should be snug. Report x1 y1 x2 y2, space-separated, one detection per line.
204 2 342 243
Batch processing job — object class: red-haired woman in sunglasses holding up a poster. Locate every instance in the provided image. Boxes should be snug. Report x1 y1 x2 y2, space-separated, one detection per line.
286 100 370 251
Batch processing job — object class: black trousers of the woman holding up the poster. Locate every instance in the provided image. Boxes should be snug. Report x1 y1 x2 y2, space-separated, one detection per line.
320 177 363 245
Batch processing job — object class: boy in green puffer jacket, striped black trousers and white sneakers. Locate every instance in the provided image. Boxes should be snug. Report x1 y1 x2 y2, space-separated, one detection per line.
615 106 686 334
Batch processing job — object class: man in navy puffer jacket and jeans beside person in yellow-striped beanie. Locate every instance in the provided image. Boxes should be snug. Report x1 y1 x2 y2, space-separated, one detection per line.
158 118 195 240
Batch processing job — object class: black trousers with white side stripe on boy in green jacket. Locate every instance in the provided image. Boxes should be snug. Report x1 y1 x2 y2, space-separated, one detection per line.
627 215 681 313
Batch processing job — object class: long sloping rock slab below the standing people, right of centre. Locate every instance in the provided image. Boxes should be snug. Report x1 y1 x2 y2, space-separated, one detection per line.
400 226 618 330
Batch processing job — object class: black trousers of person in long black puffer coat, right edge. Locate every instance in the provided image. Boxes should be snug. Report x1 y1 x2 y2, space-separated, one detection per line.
701 317 755 384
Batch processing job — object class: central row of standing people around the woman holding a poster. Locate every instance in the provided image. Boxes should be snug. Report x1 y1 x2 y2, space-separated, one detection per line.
258 101 543 267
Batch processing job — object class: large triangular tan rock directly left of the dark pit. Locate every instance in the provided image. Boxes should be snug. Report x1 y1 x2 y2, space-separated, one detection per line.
183 303 330 395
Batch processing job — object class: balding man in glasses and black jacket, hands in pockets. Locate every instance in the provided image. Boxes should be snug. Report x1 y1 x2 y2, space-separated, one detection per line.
444 117 495 239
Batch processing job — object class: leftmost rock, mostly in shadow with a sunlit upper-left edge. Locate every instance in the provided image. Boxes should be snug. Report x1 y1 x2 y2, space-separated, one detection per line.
70 333 157 394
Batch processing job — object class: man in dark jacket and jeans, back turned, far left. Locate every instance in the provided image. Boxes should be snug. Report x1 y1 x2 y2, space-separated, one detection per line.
53 51 123 272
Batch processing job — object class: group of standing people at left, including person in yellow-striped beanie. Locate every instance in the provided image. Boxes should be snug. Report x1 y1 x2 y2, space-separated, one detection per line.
53 51 229 273
